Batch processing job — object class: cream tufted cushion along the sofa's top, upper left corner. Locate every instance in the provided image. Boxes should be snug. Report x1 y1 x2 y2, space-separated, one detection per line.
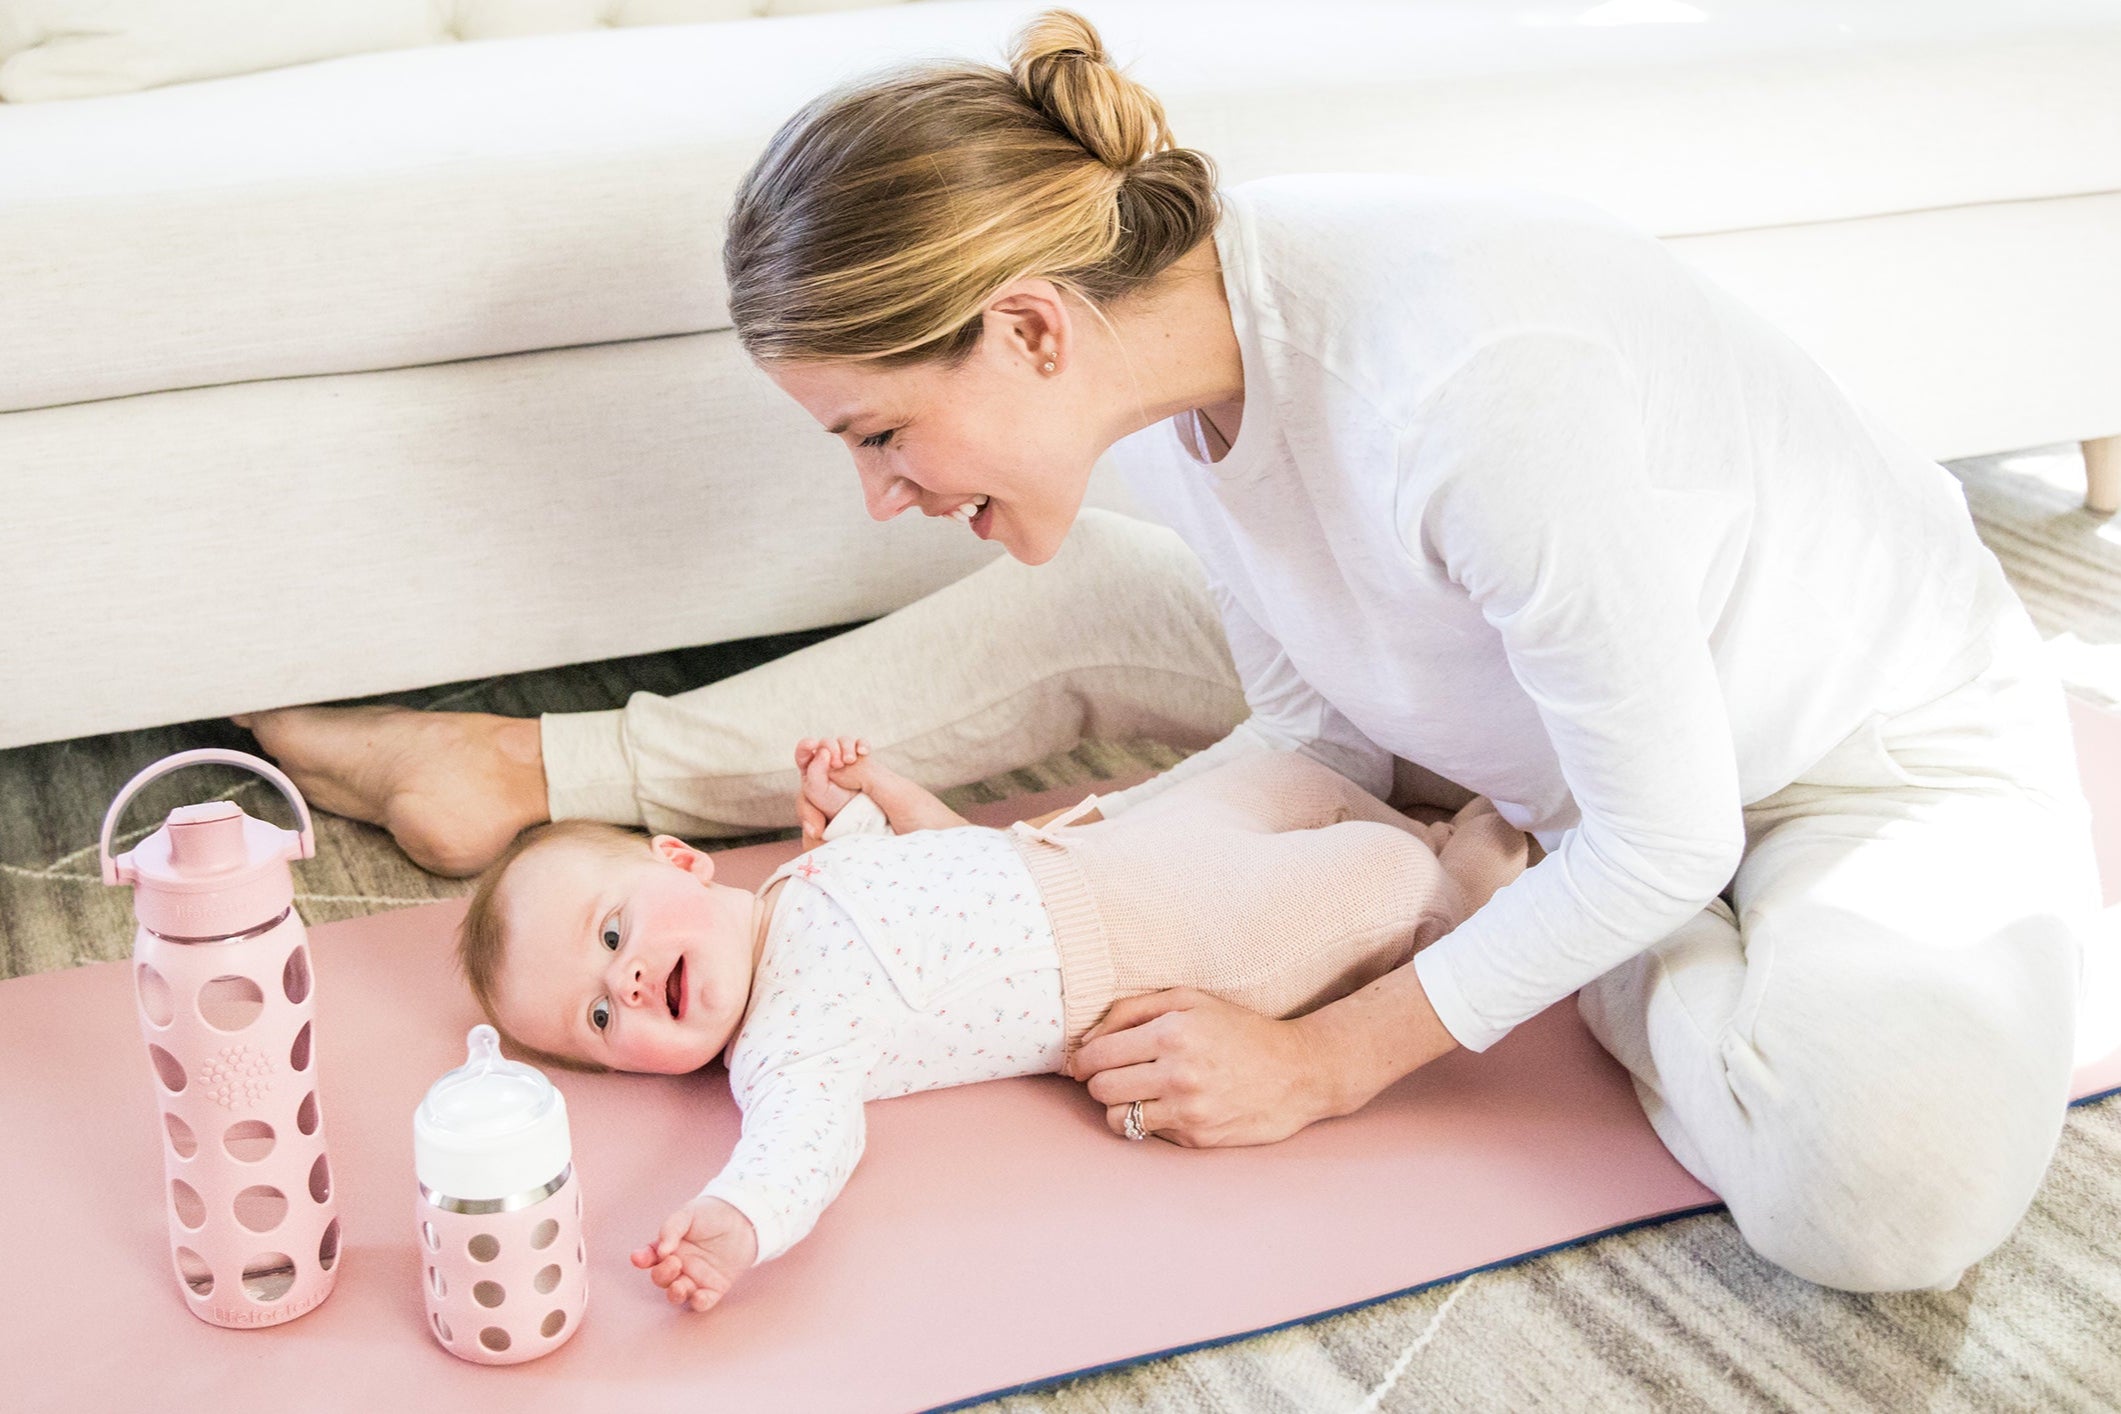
0 0 906 104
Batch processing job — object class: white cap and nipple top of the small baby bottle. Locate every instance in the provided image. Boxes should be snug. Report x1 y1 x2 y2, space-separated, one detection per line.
411 1026 573 1202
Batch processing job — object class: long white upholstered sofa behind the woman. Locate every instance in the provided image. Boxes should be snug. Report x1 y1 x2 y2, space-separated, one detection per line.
0 0 2121 746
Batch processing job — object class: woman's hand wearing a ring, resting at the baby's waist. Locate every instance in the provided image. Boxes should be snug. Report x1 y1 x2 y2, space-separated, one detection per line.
1069 988 1338 1149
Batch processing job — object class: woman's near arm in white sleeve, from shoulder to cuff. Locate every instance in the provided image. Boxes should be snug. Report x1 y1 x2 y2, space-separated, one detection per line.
1400 331 1739 1051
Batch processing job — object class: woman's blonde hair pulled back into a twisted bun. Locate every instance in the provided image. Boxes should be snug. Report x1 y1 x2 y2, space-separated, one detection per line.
721 11 1220 367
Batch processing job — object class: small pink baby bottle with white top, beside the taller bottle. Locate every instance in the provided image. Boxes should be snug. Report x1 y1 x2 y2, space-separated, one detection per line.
411 1026 588 1365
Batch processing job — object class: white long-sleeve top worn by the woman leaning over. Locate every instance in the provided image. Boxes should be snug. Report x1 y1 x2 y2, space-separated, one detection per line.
1105 176 2013 1049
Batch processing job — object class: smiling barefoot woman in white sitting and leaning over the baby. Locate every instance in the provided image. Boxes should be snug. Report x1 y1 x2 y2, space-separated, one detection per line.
240 11 2096 1289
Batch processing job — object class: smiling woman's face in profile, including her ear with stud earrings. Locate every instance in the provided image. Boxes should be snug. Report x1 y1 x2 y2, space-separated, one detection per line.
761 280 1145 564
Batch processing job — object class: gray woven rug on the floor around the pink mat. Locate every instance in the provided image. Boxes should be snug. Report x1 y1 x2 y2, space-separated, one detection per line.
0 449 2121 1414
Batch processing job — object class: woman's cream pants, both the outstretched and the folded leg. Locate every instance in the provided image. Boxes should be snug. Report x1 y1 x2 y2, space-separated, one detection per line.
543 511 2098 1291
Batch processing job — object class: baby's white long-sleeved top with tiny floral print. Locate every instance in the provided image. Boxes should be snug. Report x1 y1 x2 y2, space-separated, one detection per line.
700 795 1063 1261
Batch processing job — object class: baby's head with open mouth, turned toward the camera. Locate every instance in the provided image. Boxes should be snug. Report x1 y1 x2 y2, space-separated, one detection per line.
458 820 764 1075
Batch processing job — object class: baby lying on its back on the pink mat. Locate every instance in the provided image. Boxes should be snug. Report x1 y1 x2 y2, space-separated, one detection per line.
460 738 1527 1310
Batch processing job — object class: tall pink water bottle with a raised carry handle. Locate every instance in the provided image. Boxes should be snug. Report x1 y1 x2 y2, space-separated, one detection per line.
98 748 339 1327
